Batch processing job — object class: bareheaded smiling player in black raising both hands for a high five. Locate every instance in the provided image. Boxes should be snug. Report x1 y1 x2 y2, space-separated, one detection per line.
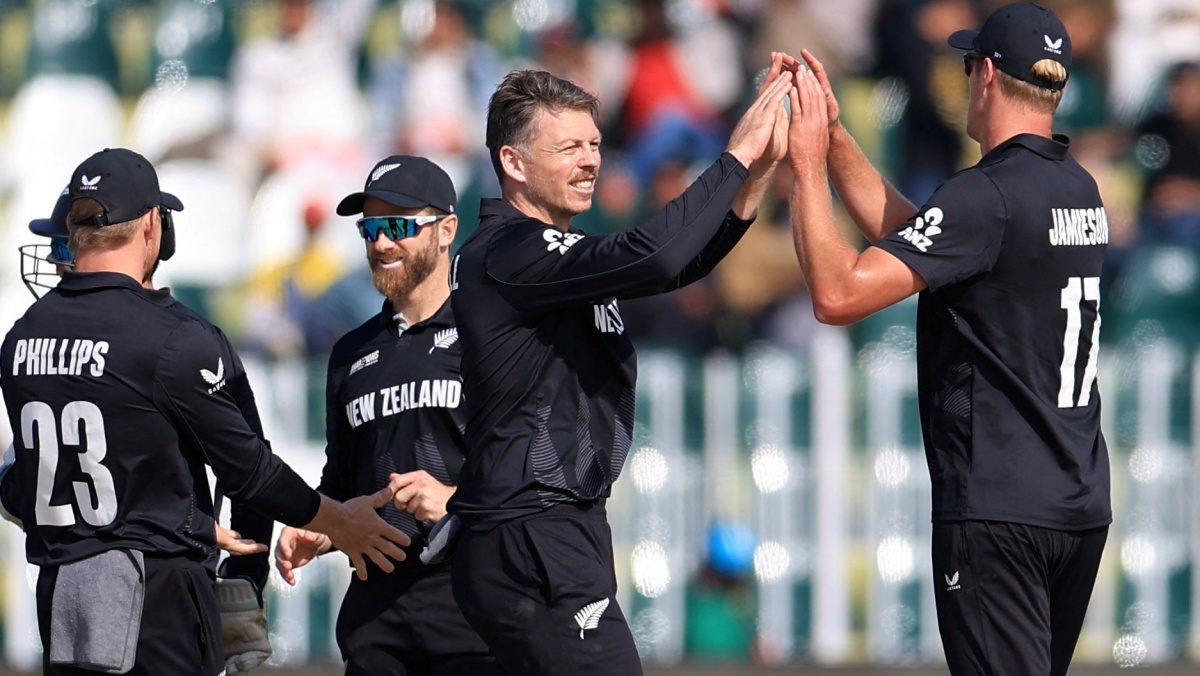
450 55 791 676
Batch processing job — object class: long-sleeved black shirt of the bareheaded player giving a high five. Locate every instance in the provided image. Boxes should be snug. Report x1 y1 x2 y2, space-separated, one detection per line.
451 154 750 527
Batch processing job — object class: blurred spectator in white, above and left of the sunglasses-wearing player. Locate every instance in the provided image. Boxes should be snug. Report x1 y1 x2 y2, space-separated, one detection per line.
232 0 376 180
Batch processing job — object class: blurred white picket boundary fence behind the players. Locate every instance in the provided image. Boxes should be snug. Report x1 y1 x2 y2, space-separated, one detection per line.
0 329 1200 668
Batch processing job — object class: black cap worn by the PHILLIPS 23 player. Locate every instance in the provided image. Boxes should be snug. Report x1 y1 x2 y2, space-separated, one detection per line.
68 148 184 226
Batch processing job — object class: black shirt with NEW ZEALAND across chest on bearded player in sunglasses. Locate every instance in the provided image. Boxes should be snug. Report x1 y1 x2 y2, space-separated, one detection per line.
317 300 467 571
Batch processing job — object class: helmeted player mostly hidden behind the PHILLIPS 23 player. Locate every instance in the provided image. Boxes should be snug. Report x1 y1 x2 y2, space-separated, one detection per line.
14 186 275 676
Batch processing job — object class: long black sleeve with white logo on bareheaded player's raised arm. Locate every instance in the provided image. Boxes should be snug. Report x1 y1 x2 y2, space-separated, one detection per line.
486 152 748 312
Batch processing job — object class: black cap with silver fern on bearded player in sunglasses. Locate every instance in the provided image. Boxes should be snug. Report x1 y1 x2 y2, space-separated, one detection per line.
337 155 457 216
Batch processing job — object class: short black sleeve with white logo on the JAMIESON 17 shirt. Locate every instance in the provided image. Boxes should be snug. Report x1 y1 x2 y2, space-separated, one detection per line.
875 169 1007 291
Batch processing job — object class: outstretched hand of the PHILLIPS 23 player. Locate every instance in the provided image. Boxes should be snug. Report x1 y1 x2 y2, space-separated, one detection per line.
319 486 412 580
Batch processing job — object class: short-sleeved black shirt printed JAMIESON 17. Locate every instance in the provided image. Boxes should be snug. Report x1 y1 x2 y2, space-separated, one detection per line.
876 134 1112 530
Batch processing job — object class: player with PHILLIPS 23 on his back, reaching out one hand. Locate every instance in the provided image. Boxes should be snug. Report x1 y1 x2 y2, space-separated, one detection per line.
0 149 409 675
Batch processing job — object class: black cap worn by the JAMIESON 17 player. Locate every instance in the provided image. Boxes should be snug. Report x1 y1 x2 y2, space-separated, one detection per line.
947 2 1070 91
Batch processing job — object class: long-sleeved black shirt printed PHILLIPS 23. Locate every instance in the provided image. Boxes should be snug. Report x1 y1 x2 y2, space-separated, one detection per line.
0 273 319 566
